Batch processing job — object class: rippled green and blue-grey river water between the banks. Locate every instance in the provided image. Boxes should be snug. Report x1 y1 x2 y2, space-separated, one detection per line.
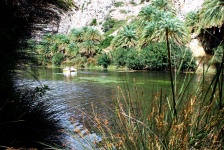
16 68 206 150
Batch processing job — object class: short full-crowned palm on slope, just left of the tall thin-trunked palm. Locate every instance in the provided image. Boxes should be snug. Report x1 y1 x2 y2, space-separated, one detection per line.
111 25 137 48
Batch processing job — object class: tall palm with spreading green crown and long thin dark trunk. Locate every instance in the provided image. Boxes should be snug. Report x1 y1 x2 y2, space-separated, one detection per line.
151 13 189 116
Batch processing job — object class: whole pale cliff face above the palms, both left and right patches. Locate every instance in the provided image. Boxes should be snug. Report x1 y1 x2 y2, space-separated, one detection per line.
58 0 204 34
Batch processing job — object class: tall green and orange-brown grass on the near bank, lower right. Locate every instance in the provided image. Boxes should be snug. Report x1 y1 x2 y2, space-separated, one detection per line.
81 46 224 150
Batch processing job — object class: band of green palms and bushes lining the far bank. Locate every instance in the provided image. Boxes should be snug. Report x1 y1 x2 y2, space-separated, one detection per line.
28 2 201 71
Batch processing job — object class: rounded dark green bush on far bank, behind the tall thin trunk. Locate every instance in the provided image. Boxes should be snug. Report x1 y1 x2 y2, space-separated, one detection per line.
140 43 196 71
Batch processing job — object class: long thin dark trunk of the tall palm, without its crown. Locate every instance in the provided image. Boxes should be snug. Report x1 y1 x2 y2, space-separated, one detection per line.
166 28 177 117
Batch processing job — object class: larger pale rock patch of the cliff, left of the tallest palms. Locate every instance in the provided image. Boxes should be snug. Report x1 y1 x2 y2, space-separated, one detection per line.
58 0 144 33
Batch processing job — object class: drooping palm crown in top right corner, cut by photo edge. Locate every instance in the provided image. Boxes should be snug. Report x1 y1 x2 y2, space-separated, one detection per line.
200 0 224 28
